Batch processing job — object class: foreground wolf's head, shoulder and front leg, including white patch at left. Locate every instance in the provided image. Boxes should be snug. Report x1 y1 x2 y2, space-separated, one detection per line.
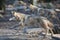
9 11 31 27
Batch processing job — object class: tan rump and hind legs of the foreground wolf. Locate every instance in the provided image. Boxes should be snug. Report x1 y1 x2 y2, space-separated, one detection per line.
40 19 54 36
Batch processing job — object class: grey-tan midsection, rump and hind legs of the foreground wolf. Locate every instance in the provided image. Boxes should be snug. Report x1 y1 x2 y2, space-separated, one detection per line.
28 17 53 36
